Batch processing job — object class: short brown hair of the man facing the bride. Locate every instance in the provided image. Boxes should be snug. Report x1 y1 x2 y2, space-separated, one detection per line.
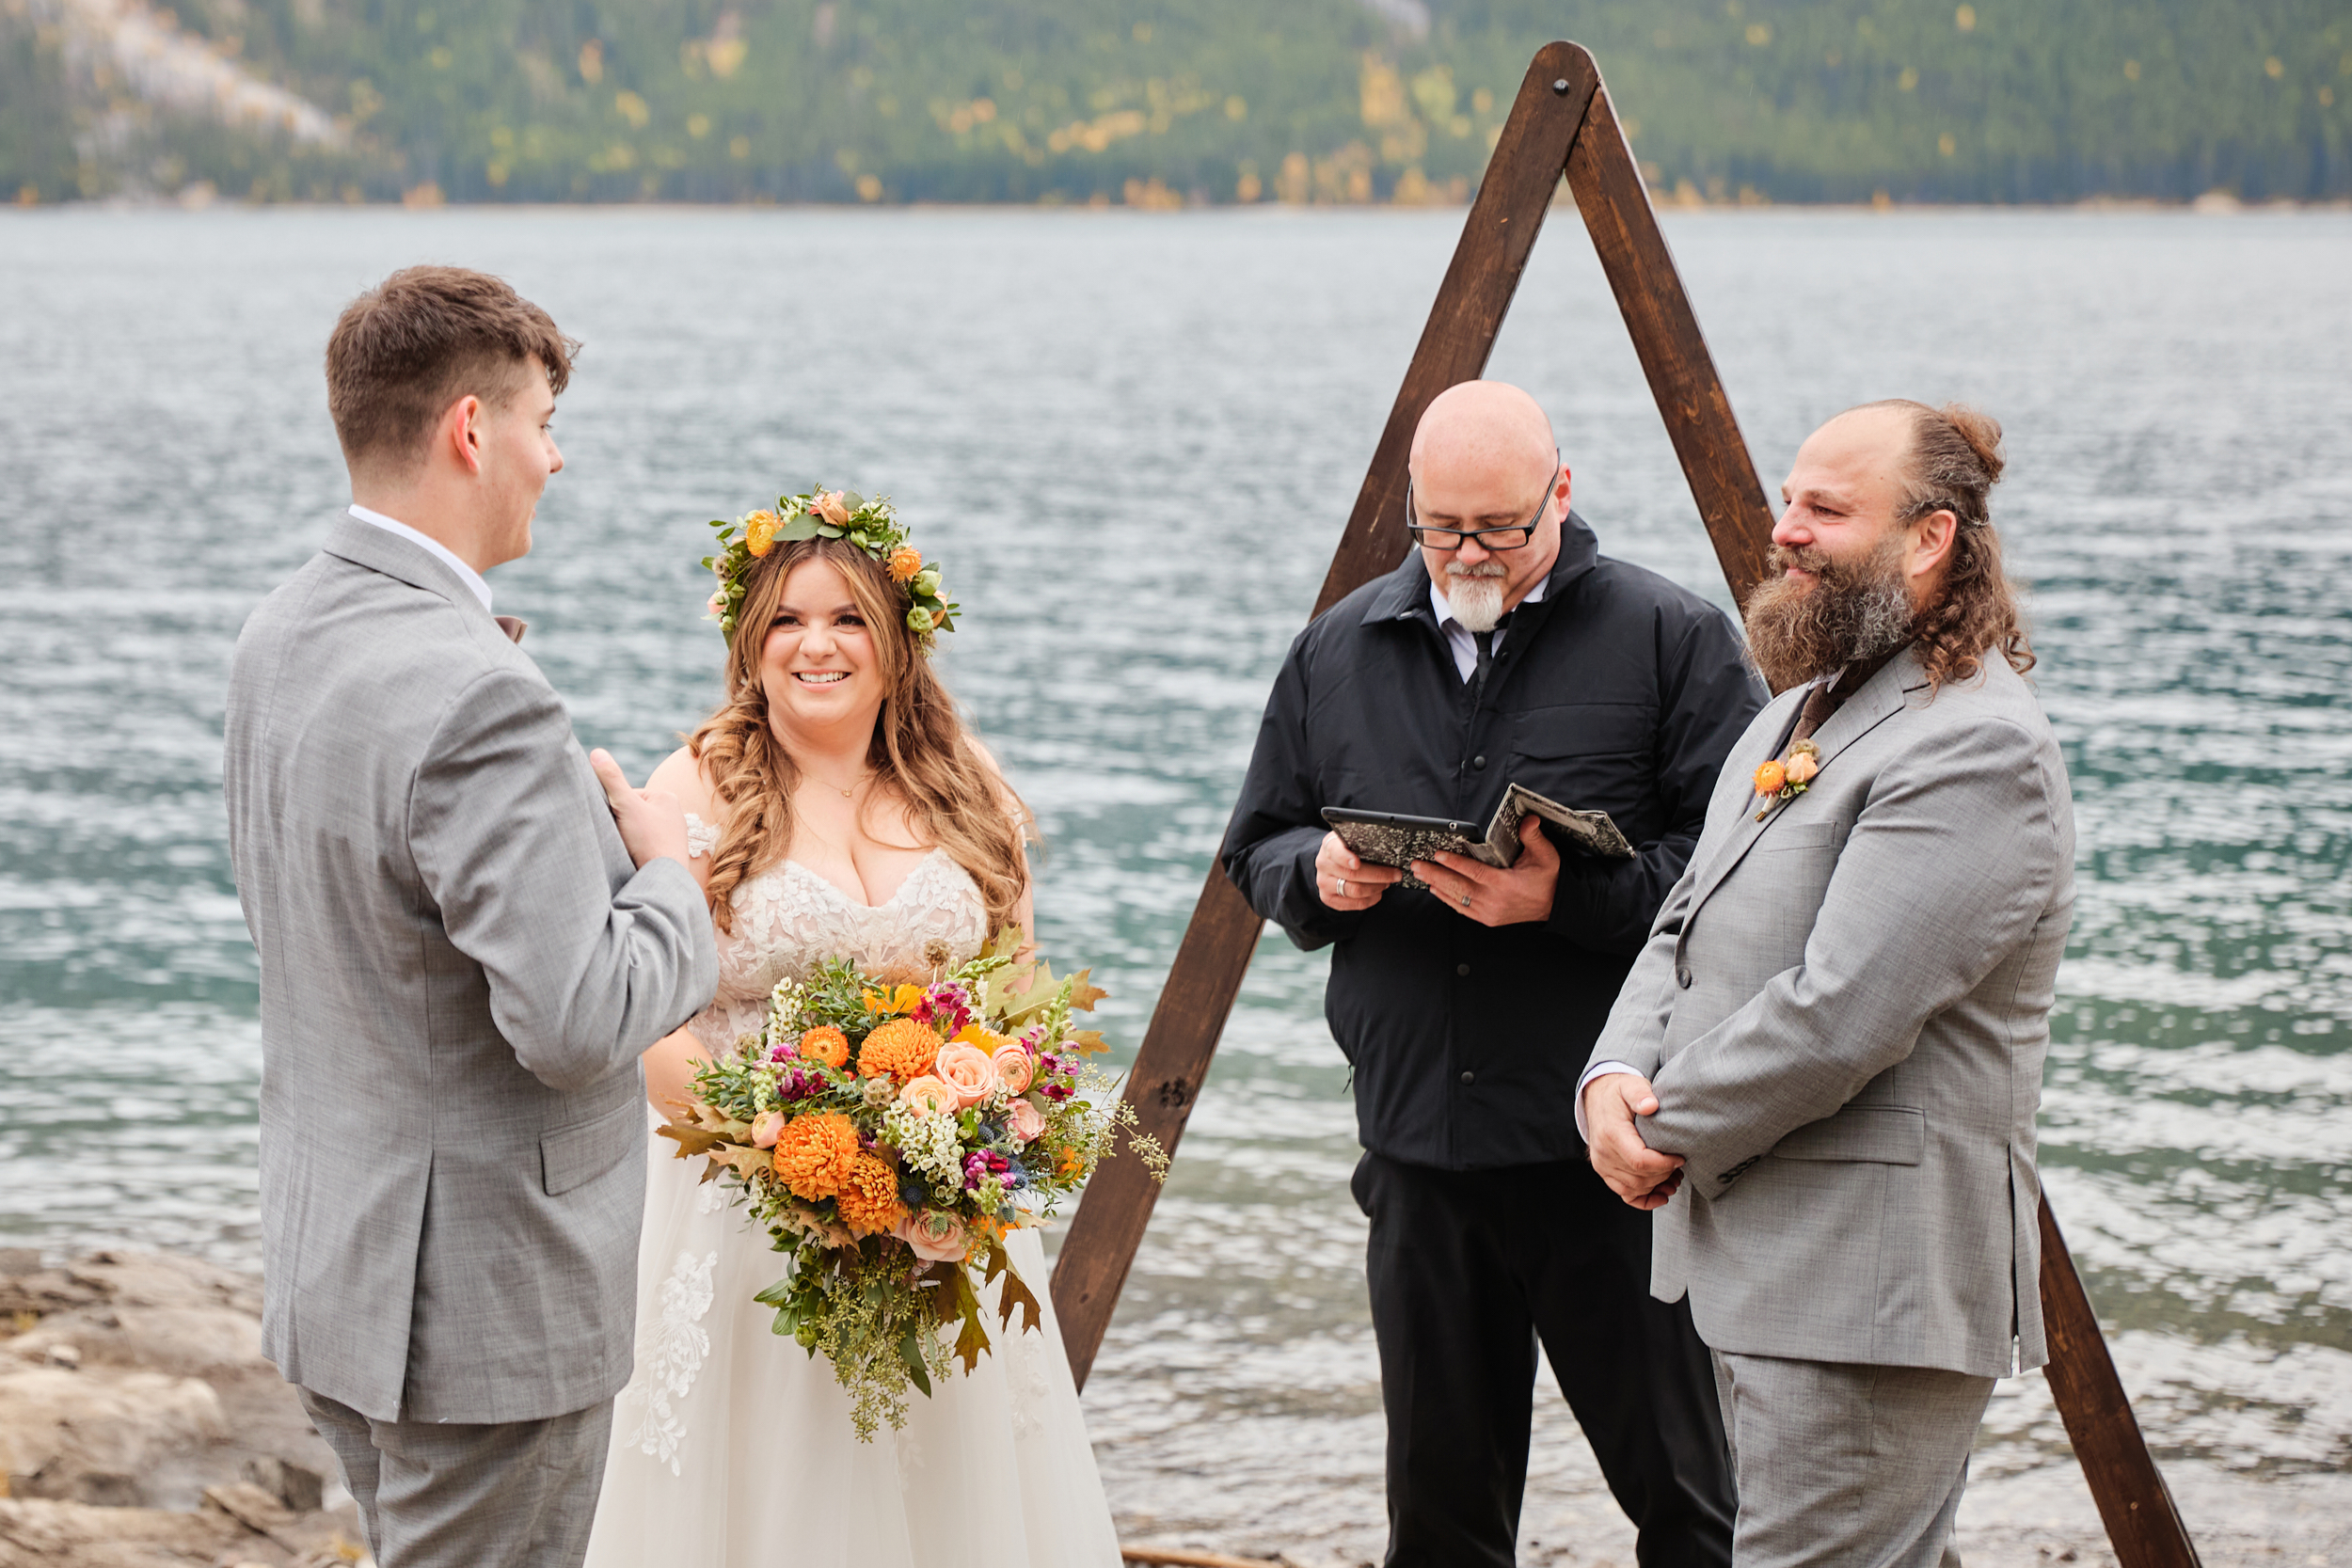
327 265 579 470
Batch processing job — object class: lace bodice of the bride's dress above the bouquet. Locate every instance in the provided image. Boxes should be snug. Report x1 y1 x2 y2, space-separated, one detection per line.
687 811 988 1053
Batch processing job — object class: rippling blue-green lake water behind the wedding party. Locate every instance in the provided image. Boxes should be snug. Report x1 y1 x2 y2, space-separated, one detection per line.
0 209 2352 1563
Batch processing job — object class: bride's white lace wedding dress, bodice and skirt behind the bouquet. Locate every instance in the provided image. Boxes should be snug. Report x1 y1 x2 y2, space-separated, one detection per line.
588 816 1120 1568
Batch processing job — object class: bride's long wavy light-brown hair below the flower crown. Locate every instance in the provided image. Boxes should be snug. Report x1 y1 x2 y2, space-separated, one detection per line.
687 538 1033 931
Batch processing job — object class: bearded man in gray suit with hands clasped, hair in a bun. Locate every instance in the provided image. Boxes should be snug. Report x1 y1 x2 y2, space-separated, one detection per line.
1579 402 2074 1568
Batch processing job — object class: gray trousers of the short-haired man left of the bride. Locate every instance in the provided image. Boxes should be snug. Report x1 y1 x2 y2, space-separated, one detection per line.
301 1389 612 1568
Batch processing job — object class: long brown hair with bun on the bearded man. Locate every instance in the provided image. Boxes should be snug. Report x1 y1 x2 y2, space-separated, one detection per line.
1863 397 2035 687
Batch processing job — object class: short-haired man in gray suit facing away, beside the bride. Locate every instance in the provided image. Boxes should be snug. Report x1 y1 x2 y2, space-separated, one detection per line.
226 268 718 1568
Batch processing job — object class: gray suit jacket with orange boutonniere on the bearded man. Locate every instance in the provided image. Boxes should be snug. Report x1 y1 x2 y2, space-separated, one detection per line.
1590 651 2074 1378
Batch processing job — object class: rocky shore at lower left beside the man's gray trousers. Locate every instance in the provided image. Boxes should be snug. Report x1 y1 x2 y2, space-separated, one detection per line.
0 1248 367 1568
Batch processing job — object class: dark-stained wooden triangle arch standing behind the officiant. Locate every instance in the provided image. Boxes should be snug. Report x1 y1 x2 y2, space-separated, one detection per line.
1054 42 2197 1568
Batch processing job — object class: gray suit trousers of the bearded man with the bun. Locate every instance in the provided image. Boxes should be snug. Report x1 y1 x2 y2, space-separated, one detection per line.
1715 1352 1993 1568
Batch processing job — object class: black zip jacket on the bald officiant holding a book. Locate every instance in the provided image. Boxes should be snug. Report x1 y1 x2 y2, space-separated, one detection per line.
1221 513 1764 1171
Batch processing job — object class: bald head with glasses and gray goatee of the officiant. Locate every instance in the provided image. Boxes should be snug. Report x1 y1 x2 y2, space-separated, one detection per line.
1409 381 1569 630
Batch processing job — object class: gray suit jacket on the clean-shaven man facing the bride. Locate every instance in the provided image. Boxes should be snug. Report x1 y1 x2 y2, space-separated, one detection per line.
226 517 718 1422
